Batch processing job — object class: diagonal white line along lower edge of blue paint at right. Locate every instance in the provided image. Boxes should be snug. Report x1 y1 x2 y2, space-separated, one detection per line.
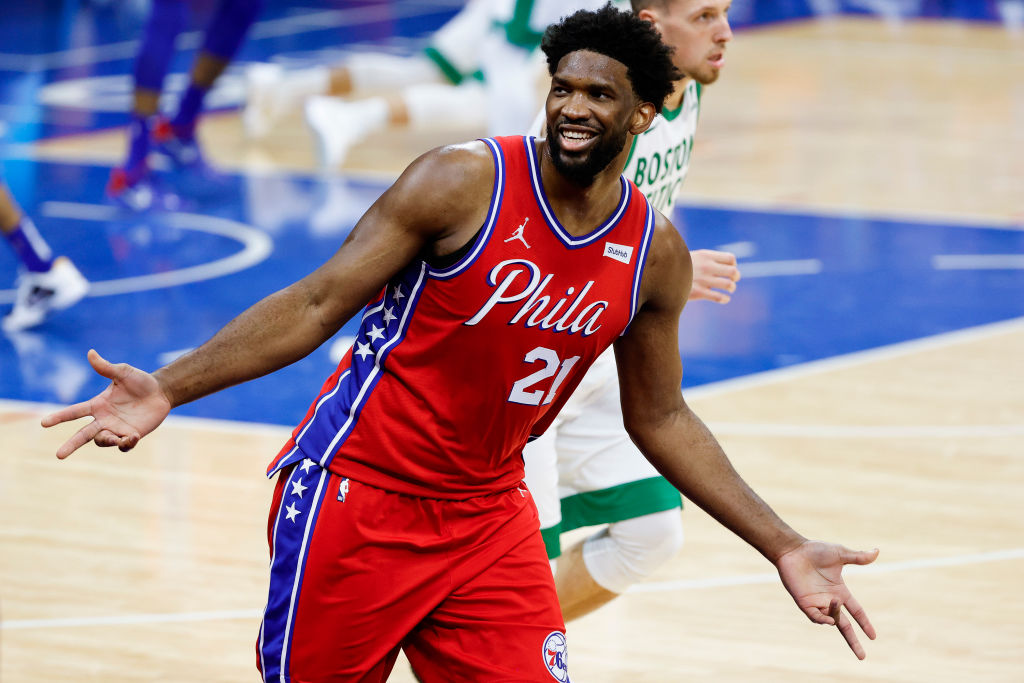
683 317 1024 398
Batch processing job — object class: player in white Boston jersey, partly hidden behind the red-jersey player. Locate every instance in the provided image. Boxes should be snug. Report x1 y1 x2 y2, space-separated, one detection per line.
523 0 739 621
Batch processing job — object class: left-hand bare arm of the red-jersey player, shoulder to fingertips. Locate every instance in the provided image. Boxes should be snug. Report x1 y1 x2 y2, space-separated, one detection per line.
42 142 494 458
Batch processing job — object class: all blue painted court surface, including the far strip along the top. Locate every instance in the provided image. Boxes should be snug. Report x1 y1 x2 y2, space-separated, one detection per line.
6 0 1024 424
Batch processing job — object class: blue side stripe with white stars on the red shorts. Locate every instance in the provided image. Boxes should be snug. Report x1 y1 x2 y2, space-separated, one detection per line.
259 460 330 683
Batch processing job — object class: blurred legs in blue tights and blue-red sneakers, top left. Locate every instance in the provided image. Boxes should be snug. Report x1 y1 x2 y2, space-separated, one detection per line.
106 0 263 211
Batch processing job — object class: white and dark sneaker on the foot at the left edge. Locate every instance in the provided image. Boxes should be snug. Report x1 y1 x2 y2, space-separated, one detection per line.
2 256 89 332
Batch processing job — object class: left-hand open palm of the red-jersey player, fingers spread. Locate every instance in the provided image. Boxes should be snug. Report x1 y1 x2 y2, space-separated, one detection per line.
42 349 171 460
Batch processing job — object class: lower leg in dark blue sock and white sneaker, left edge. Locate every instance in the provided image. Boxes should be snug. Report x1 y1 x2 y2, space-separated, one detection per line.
0 177 89 332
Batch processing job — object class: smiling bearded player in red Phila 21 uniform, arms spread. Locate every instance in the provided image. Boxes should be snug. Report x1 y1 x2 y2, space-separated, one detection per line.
43 7 877 682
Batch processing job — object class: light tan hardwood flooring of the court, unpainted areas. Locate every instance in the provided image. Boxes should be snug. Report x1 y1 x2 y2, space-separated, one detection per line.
0 14 1024 683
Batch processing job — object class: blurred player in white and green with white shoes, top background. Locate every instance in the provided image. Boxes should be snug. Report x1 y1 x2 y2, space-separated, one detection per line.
243 0 607 169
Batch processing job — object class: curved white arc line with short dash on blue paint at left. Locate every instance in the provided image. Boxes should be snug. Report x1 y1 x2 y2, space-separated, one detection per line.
0 202 273 303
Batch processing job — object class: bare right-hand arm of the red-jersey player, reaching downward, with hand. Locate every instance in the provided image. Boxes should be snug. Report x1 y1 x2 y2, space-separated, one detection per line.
615 211 878 658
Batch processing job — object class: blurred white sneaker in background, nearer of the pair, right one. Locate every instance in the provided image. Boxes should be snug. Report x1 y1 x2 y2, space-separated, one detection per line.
306 96 388 170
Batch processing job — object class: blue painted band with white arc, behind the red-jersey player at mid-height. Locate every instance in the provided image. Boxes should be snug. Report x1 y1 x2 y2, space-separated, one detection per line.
0 161 1024 424
